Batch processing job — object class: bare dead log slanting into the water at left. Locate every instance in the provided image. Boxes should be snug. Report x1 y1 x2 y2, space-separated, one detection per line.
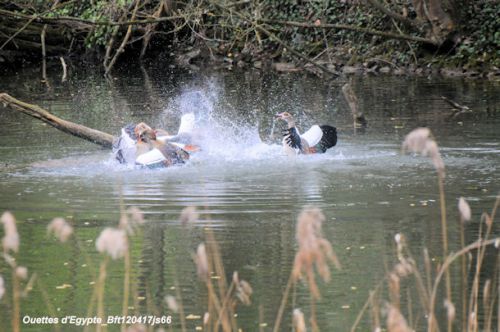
0 93 115 149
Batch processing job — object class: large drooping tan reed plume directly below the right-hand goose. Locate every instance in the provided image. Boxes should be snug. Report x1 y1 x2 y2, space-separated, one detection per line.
292 207 340 299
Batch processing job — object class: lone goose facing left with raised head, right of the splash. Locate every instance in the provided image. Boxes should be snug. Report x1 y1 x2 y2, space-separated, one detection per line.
276 112 337 155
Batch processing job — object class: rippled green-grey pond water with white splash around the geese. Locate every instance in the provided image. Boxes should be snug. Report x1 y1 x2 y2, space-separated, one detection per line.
0 62 500 331
